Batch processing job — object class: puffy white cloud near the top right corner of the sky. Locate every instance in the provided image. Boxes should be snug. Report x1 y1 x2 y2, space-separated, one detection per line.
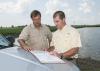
79 0 95 13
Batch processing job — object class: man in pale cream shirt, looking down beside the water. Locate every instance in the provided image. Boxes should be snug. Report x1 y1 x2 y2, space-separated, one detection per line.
48 11 82 58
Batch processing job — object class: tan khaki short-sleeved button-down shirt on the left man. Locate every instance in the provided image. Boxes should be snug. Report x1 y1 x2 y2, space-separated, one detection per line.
19 24 52 50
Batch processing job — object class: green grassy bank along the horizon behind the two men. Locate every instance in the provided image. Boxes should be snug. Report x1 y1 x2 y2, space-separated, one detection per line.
0 25 100 36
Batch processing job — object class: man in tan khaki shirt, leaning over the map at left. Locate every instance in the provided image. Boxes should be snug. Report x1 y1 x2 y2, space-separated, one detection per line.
18 10 52 51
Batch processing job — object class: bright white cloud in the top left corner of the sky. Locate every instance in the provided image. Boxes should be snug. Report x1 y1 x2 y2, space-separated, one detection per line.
0 0 34 13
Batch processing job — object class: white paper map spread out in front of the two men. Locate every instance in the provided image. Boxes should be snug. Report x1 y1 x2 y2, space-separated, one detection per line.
31 51 65 63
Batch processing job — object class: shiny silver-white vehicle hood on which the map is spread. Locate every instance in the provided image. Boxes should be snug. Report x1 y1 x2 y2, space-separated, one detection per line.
0 37 80 71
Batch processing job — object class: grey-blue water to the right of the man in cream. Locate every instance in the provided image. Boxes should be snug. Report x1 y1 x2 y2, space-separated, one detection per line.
15 27 100 60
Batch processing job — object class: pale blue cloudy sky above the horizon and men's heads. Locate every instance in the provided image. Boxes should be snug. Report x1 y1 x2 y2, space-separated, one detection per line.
0 0 100 27
